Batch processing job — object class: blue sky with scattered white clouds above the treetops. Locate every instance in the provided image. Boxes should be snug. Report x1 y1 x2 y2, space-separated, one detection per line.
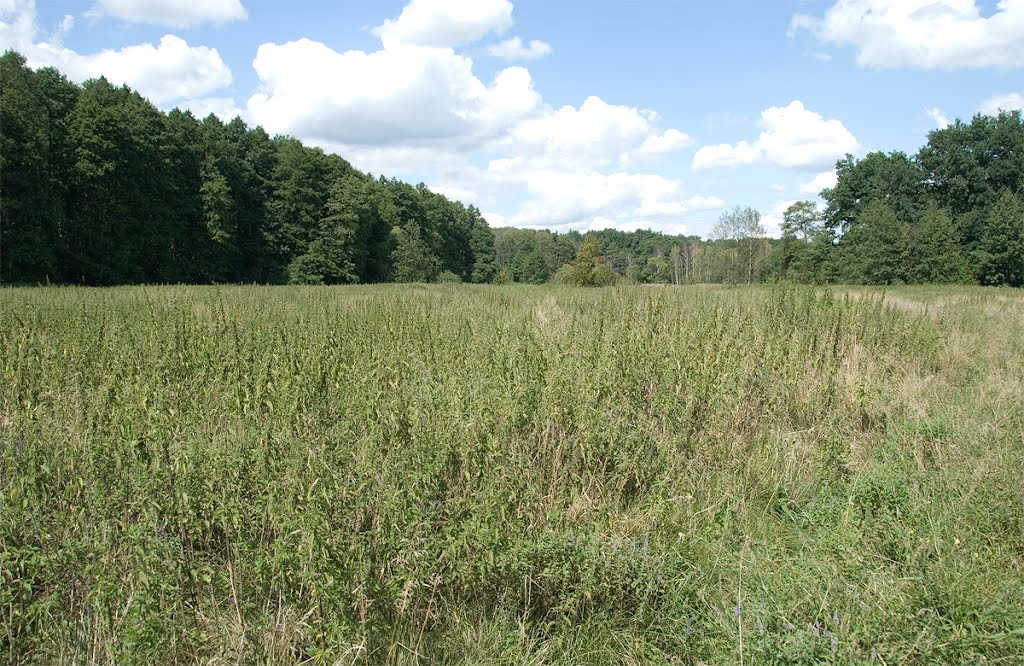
0 0 1024 237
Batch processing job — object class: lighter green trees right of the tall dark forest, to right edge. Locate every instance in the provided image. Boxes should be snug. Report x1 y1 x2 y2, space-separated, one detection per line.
496 111 1024 287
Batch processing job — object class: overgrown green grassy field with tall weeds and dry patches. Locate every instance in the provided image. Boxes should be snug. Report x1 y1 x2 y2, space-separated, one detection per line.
0 286 1024 665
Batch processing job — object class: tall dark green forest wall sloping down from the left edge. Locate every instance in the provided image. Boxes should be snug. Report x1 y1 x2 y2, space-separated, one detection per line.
0 51 497 285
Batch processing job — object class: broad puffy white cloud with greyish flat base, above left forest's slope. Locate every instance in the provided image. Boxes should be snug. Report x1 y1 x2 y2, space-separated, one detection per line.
249 39 540 147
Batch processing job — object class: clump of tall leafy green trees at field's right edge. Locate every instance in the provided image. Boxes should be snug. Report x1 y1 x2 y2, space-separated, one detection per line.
775 111 1024 287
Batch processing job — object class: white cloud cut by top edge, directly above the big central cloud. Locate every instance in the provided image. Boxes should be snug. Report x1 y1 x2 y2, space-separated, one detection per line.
374 0 512 48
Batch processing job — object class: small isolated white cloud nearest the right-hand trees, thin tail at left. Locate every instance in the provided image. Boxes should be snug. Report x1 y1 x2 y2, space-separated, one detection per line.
693 100 859 171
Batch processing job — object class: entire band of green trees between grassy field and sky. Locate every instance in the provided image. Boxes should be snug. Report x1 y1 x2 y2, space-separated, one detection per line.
0 51 1024 286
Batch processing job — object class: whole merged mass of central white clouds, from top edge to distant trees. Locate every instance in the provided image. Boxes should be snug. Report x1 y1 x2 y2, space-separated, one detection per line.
248 0 712 235
